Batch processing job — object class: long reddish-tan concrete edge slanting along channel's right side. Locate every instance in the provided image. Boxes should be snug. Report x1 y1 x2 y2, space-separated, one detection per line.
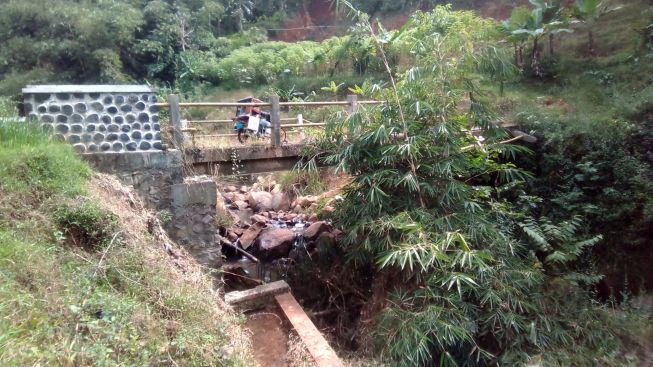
275 292 344 367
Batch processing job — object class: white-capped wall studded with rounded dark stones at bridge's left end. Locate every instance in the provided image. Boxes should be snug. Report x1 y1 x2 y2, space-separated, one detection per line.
23 85 164 153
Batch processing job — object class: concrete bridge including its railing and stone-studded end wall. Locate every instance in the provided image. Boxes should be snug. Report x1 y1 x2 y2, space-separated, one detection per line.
23 85 533 175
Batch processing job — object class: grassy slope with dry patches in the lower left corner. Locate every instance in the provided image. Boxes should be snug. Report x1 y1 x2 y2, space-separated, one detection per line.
0 124 253 366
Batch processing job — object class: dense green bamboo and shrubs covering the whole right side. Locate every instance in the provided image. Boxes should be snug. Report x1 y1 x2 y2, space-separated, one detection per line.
292 1 653 366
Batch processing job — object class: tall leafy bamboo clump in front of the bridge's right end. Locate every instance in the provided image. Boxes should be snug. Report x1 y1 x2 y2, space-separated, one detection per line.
298 1 648 366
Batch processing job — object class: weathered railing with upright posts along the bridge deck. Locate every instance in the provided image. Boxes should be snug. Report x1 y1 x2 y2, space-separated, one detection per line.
156 94 383 147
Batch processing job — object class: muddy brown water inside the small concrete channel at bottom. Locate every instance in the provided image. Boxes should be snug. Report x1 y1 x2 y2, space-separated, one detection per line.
245 310 289 367
